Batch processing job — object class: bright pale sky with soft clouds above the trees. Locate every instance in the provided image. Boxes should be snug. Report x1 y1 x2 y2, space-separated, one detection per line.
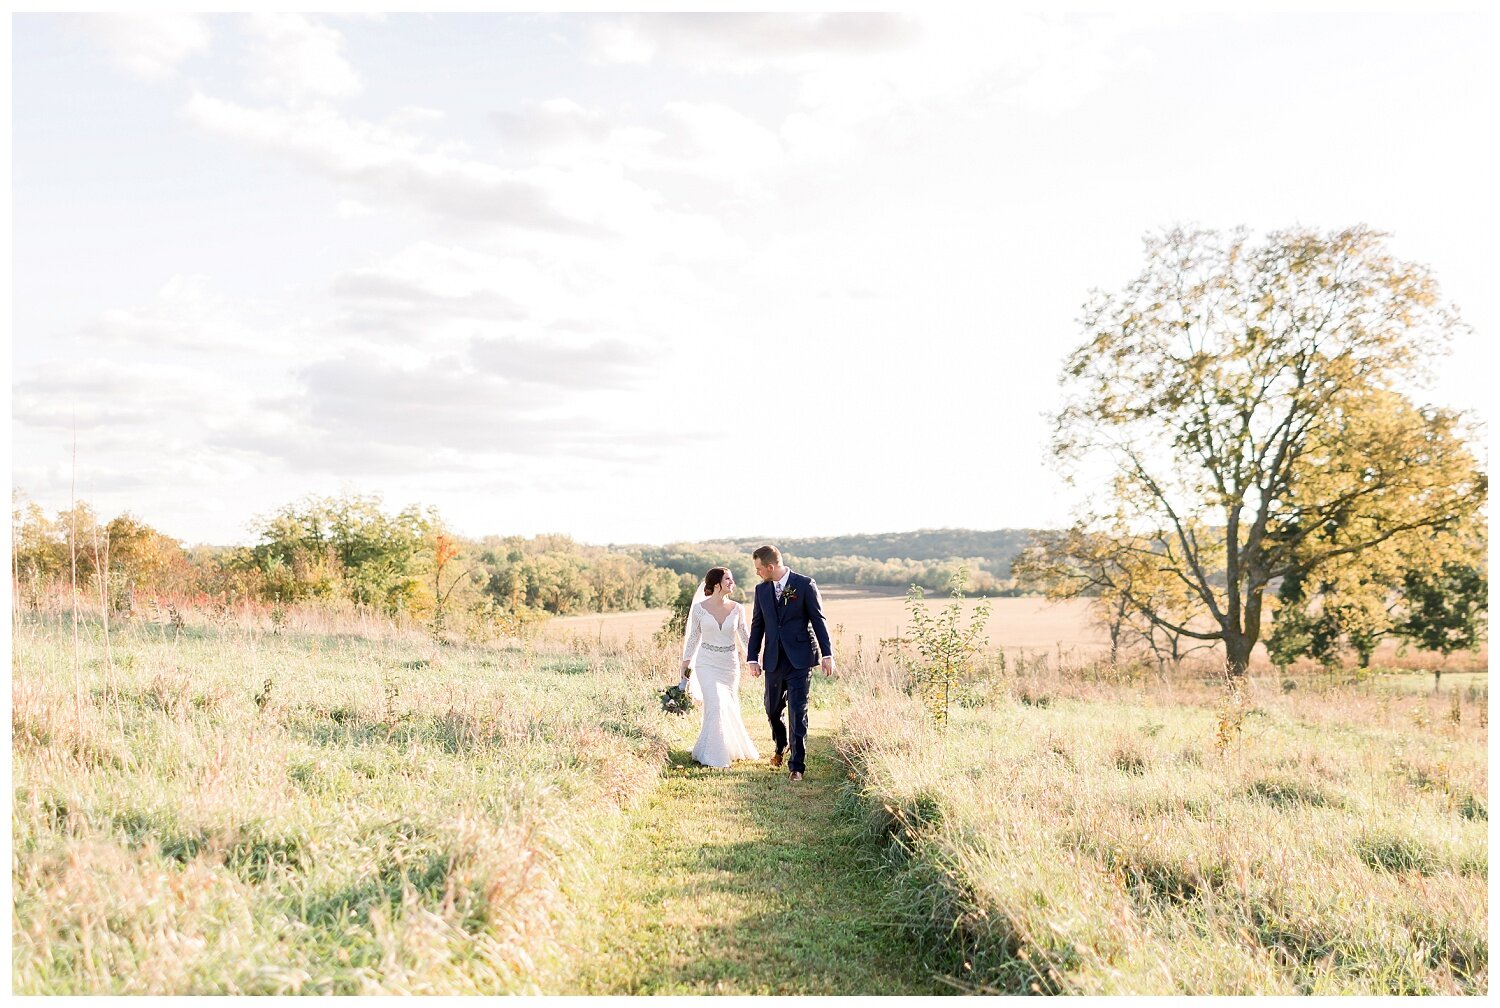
12 11 1497 545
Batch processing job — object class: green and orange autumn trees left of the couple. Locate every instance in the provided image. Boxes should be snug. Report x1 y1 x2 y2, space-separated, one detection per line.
12 494 683 623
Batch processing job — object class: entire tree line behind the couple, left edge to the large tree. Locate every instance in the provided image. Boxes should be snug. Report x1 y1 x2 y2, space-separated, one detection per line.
12 492 1026 639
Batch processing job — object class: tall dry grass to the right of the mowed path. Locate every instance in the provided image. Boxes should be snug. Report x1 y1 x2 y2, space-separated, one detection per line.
839 639 1488 995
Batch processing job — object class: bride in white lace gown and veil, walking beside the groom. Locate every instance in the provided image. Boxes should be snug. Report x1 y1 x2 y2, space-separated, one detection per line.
683 567 761 768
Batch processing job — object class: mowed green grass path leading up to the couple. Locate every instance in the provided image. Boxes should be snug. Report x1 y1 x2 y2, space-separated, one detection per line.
569 693 954 995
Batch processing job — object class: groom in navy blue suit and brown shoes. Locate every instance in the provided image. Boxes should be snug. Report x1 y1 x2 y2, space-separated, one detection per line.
747 546 834 780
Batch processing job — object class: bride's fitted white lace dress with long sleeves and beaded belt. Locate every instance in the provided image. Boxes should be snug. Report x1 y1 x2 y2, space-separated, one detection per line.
683 603 761 768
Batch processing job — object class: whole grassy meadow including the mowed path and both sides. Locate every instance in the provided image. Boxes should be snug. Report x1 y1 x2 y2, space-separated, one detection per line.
12 599 1488 995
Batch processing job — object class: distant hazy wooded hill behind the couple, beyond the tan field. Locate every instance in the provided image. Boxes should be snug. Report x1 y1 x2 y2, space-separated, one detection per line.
615 528 1032 594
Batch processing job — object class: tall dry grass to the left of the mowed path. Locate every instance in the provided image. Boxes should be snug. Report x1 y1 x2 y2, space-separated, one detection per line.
12 606 681 995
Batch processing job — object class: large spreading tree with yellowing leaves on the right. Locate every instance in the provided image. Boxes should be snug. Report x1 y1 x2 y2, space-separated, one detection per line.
1053 227 1487 677
